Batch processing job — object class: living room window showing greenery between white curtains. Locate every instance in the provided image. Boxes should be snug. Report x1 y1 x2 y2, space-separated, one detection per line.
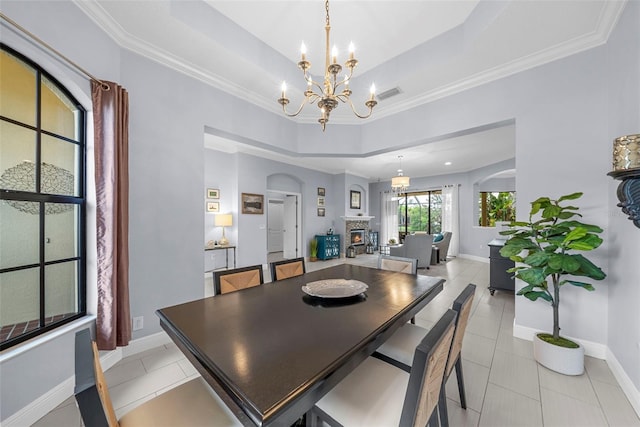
398 190 442 239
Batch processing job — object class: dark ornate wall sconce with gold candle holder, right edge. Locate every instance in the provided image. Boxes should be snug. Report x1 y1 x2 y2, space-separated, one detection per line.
607 134 640 228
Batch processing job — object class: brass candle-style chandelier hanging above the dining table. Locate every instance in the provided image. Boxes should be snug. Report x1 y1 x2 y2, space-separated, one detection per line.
278 0 378 132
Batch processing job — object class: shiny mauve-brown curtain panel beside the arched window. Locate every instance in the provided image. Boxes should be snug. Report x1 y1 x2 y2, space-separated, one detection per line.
91 81 131 350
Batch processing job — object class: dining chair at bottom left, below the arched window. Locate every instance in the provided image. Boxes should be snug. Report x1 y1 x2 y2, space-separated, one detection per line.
74 329 242 427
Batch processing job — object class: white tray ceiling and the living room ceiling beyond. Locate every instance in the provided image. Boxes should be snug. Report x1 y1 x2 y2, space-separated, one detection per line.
74 0 625 180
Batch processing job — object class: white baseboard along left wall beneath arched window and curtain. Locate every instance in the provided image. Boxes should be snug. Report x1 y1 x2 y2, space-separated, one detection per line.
0 332 171 427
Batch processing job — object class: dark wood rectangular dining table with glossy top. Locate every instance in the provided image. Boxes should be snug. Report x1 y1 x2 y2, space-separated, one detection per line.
157 264 444 426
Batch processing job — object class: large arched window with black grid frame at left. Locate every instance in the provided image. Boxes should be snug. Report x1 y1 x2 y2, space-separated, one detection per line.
0 44 86 349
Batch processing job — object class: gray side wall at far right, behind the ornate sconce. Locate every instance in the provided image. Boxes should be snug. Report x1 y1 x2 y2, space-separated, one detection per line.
602 1 640 393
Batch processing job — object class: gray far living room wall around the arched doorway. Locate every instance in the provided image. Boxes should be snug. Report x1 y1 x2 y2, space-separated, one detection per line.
201 149 350 266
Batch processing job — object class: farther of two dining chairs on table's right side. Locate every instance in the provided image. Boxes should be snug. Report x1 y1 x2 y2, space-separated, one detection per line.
374 283 476 427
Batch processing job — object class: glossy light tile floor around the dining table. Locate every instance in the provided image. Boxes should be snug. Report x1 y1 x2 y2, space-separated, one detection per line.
34 255 640 427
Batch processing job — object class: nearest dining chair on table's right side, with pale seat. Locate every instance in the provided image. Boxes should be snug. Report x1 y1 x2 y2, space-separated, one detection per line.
307 310 456 427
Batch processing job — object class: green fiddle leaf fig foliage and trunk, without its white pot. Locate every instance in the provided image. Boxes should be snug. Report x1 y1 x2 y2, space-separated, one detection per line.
500 193 606 347
